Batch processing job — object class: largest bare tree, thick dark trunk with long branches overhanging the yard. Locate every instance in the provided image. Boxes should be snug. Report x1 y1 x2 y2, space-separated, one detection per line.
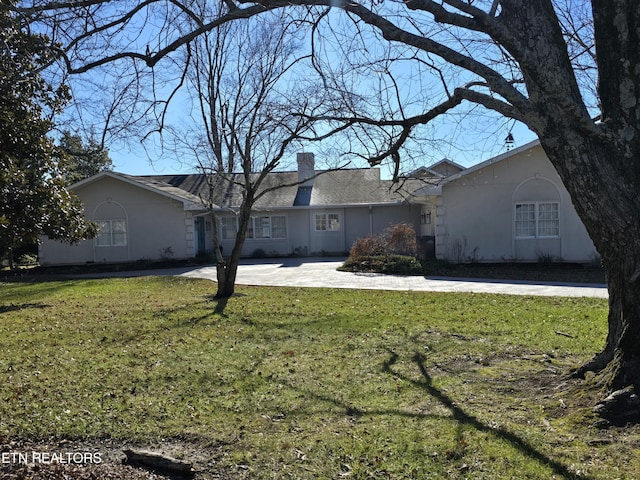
9 0 640 412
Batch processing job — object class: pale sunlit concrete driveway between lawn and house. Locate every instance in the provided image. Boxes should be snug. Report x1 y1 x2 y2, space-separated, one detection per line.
176 258 608 298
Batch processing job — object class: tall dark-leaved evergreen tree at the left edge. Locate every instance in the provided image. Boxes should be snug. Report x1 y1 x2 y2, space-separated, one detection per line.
0 6 96 267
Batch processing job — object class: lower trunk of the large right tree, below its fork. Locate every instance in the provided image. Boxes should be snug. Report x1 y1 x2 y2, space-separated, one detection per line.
542 132 640 391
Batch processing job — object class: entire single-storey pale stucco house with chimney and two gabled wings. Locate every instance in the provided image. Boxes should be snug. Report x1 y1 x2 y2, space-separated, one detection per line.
39 141 596 265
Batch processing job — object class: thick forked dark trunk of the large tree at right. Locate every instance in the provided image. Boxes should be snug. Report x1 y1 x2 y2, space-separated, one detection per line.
500 0 640 404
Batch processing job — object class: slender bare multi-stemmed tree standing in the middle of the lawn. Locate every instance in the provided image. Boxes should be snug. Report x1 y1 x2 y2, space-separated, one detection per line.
168 6 330 298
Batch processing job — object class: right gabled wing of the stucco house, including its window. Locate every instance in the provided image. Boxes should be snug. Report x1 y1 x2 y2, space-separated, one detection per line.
413 140 598 262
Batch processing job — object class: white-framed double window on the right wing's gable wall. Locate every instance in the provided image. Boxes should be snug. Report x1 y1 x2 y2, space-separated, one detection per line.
513 202 560 239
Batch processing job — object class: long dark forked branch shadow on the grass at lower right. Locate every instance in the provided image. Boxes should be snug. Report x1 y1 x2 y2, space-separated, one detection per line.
382 350 591 480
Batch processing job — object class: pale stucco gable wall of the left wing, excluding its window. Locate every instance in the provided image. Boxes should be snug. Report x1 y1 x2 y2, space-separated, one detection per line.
40 177 194 265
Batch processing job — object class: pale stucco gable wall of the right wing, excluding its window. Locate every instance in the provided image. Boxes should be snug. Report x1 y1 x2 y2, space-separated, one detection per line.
435 146 596 262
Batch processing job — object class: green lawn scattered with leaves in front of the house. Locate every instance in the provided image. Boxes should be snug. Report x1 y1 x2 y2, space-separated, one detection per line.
0 277 640 479
